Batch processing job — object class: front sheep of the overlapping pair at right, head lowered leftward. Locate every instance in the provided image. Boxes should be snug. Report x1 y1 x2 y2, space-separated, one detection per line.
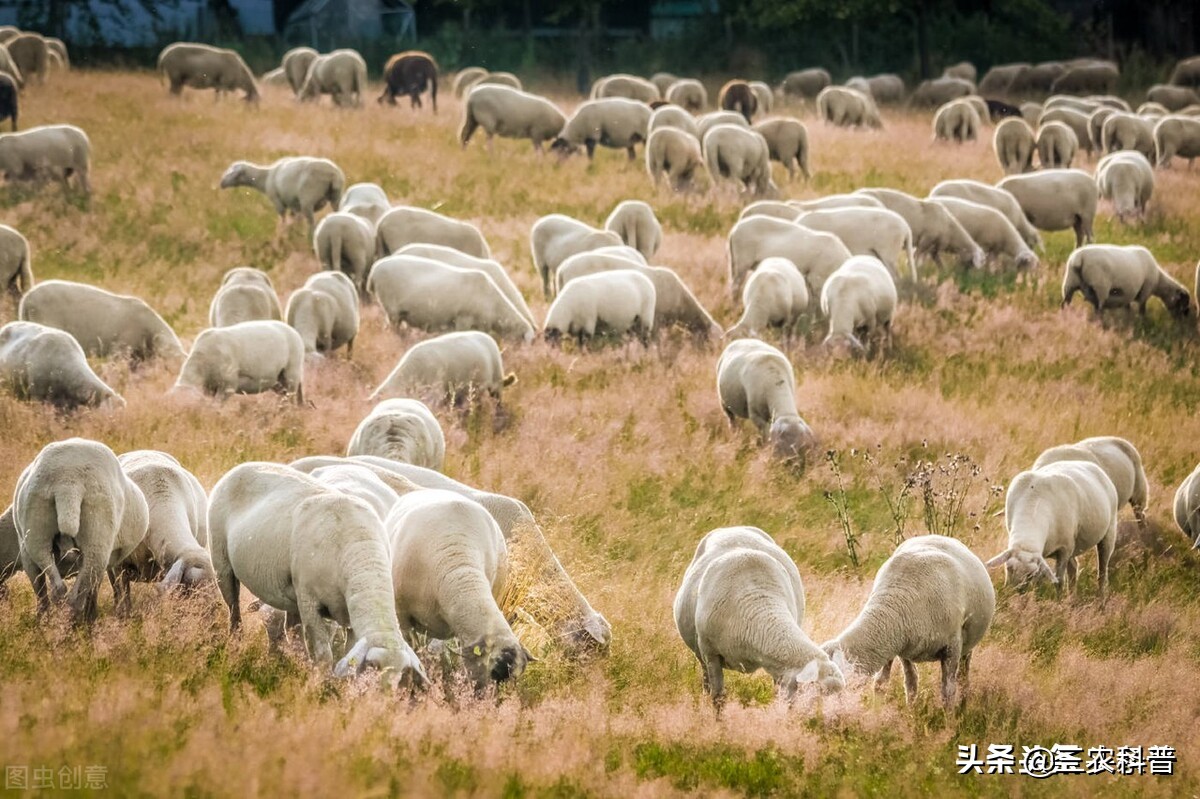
988 461 1117 599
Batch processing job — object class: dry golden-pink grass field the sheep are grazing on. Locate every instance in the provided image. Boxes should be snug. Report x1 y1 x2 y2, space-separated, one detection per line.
0 72 1200 798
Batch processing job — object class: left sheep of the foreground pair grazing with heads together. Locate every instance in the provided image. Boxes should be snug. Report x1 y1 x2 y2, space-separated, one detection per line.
674 527 846 710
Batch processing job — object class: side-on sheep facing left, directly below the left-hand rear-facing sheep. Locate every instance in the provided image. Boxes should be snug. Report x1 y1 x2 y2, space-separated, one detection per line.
175 320 304 405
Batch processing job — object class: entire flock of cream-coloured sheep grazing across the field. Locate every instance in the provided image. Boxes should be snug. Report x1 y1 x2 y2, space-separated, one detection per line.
0 35 1200 707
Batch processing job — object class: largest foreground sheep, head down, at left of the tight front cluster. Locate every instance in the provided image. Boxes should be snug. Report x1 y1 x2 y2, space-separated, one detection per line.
209 462 427 686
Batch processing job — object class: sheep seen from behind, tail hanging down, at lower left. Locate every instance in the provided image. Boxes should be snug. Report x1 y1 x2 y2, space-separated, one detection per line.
12 438 149 624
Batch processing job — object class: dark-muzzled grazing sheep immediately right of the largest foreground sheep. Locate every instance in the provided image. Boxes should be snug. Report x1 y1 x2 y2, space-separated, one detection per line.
385 488 533 691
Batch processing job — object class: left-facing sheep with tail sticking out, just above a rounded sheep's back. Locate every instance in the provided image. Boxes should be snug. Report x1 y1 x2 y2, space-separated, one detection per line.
371 330 517 404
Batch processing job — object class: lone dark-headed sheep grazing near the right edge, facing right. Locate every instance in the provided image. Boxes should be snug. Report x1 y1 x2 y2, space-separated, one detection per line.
1062 245 1192 318
